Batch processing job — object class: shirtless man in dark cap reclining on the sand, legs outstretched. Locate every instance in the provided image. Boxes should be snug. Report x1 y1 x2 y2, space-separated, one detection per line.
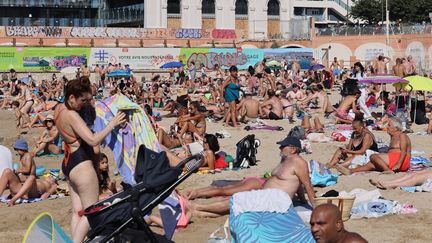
185 137 315 217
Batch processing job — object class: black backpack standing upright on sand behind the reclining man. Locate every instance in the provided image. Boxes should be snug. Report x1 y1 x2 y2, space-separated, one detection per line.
234 134 261 168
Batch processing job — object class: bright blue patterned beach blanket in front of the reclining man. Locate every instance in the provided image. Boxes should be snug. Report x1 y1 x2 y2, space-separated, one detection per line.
229 192 315 243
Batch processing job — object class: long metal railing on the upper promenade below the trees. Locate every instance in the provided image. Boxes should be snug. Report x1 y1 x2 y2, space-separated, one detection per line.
315 24 432 36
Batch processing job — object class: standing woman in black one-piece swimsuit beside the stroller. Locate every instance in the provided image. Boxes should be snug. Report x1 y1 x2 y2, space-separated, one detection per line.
55 78 125 242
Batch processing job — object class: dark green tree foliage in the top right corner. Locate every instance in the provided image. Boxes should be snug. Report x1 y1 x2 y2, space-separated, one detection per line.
350 0 432 23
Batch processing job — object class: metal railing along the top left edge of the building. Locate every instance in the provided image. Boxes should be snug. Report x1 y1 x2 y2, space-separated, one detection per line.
0 0 101 8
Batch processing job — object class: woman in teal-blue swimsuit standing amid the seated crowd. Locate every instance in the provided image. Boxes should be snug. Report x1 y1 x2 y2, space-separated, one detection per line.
222 66 240 127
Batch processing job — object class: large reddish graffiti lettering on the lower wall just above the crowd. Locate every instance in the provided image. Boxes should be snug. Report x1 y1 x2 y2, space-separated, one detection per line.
188 52 248 69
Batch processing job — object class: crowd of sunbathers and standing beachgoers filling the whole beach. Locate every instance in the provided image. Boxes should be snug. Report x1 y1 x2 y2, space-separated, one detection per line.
0 53 432 242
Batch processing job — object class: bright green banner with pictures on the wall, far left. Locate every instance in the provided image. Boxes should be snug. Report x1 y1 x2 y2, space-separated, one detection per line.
0 47 90 71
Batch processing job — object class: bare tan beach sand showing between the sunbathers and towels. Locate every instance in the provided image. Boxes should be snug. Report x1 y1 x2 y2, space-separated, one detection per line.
0 89 432 243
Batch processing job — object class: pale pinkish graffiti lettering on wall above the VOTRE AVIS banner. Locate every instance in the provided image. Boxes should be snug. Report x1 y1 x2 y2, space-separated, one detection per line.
70 27 143 38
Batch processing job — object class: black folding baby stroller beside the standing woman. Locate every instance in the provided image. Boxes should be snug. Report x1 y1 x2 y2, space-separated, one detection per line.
80 145 203 242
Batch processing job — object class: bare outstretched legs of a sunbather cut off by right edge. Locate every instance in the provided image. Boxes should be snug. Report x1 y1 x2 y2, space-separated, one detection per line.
369 170 432 190
